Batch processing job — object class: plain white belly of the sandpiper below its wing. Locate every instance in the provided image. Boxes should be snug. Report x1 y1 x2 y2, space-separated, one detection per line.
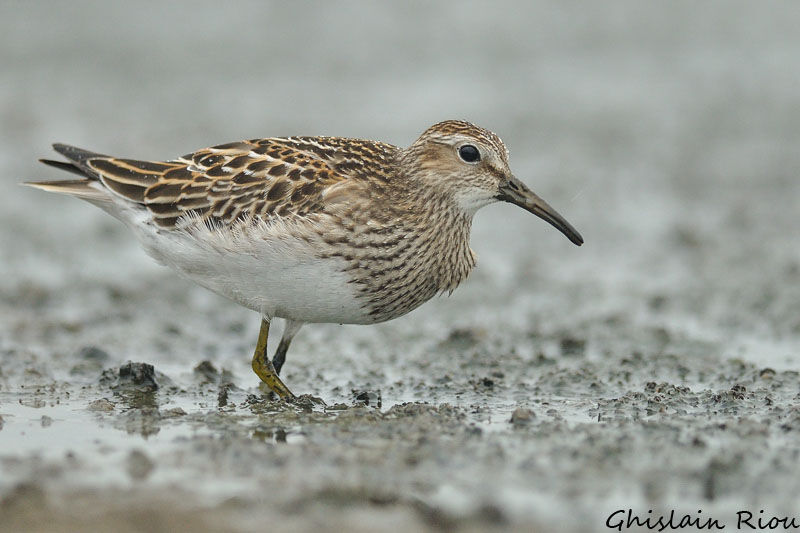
129 214 374 324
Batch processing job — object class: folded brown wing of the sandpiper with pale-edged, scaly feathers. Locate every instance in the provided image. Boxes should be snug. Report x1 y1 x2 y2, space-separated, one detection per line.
84 137 397 228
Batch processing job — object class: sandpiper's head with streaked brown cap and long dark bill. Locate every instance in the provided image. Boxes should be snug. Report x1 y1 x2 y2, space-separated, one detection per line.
404 120 583 246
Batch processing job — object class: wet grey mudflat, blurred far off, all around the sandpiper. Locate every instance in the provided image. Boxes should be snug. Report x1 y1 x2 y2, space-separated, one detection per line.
0 0 800 530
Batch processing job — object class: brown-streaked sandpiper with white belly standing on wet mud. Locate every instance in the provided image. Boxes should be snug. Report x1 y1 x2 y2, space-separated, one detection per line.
24 120 583 401
